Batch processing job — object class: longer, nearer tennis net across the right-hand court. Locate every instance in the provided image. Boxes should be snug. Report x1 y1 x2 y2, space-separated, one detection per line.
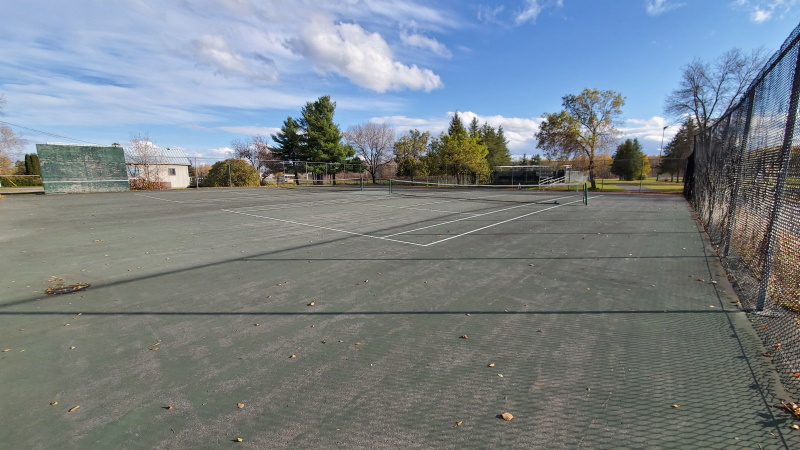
389 179 587 204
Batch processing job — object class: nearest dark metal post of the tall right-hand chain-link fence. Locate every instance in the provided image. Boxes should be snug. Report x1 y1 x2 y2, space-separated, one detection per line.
756 46 800 311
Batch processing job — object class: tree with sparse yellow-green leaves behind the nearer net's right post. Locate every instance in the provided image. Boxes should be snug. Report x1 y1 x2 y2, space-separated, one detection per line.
535 89 625 189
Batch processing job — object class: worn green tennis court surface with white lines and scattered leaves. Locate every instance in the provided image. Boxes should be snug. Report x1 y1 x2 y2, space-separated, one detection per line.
0 188 800 449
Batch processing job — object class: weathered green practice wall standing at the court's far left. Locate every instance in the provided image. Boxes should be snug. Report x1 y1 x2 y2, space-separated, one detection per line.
36 144 130 194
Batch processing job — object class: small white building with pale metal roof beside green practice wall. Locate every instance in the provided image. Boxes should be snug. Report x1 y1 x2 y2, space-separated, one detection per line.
125 146 191 189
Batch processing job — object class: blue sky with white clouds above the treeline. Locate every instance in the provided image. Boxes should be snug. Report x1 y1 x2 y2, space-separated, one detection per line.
0 0 800 162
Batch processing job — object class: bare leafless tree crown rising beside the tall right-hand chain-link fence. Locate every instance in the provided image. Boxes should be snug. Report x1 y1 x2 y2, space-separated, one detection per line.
664 48 767 136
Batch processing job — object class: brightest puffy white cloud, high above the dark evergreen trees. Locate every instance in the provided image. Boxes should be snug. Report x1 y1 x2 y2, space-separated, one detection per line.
290 16 443 93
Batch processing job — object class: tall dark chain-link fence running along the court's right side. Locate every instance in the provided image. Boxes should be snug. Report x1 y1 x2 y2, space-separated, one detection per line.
687 26 800 395
